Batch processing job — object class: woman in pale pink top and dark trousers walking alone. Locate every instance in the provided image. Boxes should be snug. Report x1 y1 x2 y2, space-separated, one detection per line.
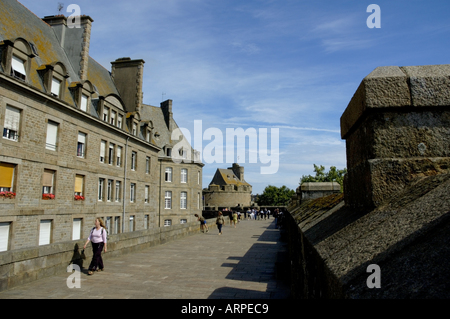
83 218 107 275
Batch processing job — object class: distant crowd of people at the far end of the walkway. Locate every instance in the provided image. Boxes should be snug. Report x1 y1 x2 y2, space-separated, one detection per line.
195 208 283 235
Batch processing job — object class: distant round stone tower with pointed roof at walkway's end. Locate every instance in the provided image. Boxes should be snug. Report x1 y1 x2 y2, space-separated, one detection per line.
203 163 252 209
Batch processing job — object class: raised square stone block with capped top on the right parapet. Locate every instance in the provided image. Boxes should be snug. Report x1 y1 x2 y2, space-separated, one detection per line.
341 65 450 209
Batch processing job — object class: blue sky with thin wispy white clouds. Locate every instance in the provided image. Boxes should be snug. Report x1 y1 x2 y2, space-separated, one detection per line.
15 0 450 194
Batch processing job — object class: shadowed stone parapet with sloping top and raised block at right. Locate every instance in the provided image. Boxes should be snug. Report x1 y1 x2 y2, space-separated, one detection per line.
284 65 450 299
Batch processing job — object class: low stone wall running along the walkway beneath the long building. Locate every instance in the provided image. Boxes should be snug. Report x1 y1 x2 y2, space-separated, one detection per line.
0 219 216 291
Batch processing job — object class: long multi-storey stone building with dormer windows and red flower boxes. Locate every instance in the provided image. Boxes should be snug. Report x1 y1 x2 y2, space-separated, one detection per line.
0 0 203 289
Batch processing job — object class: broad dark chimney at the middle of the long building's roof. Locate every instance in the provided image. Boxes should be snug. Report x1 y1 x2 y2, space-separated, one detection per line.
111 58 145 112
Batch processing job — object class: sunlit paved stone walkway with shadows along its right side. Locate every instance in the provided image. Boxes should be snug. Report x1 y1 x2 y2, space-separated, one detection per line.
0 219 289 299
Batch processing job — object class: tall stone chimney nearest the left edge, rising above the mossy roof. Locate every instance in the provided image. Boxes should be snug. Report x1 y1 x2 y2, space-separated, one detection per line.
42 15 94 81
